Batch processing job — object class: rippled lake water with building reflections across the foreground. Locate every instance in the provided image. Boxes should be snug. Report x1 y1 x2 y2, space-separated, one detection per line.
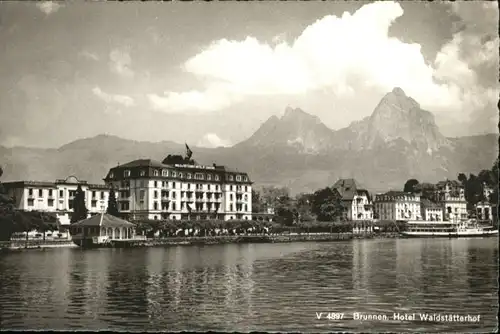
0 238 498 332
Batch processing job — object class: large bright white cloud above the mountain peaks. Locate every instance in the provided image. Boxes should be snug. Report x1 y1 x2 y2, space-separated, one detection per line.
153 1 496 118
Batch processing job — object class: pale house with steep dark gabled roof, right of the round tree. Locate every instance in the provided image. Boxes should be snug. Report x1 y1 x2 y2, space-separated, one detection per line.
333 179 373 221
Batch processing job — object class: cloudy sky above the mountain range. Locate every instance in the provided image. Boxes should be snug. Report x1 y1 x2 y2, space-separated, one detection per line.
0 1 499 147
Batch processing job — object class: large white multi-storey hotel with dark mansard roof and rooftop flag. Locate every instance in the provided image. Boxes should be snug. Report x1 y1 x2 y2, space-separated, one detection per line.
104 152 252 220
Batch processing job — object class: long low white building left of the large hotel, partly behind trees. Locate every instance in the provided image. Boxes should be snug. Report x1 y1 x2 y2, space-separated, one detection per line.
2 176 109 226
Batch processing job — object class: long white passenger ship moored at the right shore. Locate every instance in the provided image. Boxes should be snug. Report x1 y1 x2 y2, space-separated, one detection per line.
401 220 498 238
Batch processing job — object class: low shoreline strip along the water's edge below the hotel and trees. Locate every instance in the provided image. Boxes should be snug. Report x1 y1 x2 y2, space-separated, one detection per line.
0 232 399 252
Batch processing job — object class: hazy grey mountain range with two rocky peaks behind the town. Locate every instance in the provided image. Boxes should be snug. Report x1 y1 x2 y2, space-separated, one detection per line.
0 88 498 193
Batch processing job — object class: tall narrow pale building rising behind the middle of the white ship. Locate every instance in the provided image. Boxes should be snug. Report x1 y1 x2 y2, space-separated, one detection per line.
436 180 468 220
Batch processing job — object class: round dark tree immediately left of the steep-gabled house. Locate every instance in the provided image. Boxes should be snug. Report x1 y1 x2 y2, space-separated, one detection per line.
311 187 344 221
